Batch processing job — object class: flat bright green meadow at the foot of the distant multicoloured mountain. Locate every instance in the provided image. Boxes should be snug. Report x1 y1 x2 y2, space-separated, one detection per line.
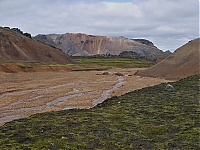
74 58 154 68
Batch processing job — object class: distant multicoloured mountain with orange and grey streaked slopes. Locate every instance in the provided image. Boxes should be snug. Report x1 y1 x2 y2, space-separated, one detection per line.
34 33 169 60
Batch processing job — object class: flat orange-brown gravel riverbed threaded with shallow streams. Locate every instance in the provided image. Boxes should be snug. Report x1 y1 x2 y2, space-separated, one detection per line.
0 68 172 125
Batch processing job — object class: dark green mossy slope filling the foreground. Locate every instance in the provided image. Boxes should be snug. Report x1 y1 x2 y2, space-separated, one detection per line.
0 75 200 150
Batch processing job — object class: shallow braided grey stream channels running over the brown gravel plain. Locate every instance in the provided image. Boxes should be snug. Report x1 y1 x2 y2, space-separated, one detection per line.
0 76 124 125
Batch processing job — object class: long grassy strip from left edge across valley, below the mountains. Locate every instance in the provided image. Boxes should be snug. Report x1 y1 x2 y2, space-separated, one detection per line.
0 58 154 72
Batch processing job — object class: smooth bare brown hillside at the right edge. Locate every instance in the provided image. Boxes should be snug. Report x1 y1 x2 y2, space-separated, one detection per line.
136 38 200 79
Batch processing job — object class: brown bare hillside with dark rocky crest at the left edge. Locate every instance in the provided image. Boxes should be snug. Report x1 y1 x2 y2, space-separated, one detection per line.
0 27 73 63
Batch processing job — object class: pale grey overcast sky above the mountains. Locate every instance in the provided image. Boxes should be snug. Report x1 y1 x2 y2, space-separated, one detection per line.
0 0 199 51
